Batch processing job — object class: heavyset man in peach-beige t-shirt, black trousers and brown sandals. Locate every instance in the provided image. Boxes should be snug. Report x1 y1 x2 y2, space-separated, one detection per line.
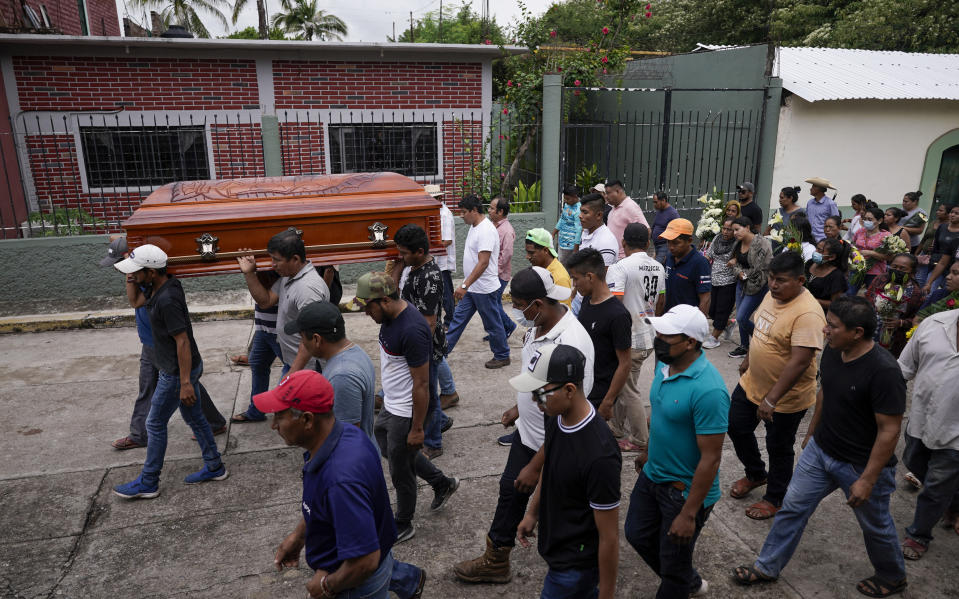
728 252 826 520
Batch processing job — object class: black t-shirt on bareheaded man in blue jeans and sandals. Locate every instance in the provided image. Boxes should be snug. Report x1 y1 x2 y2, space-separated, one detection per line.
815 343 906 468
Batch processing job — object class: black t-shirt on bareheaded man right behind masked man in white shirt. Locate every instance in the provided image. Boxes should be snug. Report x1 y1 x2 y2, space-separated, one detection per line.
578 297 633 406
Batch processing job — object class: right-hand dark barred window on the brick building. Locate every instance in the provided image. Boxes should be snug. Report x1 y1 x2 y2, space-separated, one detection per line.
329 123 439 177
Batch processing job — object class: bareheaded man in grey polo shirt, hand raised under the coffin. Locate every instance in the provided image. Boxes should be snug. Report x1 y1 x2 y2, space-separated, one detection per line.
231 229 330 423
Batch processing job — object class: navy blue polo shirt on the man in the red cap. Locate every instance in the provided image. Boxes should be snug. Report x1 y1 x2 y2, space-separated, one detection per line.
302 421 396 572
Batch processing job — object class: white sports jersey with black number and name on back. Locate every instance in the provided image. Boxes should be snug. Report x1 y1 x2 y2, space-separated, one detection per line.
606 252 666 349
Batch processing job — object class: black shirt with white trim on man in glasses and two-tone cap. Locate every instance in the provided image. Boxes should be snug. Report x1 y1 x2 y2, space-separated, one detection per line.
538 410 623 570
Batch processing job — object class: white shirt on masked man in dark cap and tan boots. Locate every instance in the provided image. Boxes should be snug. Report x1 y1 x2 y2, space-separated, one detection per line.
516 306 595 451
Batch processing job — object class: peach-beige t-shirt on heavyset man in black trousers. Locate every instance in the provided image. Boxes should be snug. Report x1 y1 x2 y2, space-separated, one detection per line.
739 289 826 414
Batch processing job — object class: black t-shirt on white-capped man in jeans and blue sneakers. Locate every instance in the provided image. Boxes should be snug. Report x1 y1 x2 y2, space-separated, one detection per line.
146 276 200 374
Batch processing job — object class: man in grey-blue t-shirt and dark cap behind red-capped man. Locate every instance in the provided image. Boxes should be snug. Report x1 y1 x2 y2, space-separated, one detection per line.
285 301 376 442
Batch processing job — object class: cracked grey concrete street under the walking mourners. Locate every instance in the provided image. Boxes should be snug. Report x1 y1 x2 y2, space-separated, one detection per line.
0 302 959 599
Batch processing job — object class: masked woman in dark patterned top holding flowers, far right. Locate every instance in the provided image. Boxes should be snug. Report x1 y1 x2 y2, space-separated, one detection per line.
866 251 924 358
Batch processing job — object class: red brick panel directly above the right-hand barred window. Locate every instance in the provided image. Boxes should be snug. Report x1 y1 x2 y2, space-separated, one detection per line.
273 60 483 110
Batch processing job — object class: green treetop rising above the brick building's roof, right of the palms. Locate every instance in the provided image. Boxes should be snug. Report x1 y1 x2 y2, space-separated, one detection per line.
386 2 506 45
